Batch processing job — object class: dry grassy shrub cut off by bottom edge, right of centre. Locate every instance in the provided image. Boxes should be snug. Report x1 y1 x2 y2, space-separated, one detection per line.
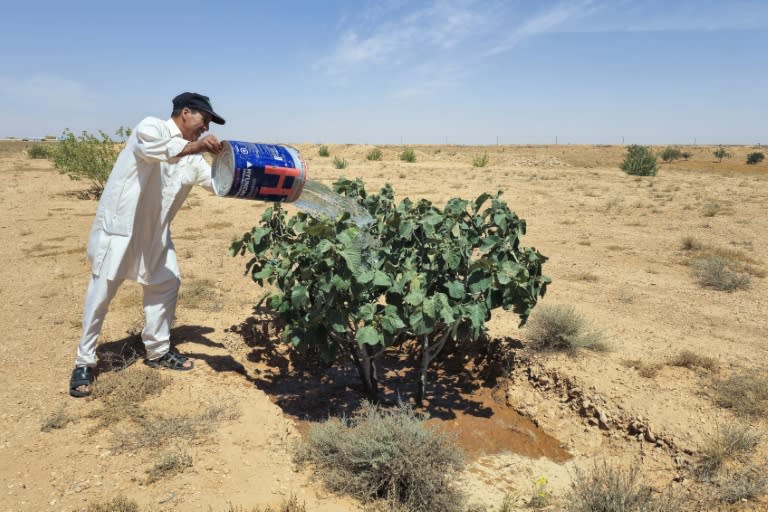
565 461 681 512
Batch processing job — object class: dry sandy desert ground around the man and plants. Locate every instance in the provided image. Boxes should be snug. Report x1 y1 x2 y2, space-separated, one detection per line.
0 142 768 512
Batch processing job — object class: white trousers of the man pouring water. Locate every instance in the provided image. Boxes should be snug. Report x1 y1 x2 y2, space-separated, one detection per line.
75 275 181 366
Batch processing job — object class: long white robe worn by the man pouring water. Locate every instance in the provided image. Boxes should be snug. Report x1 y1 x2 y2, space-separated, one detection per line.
88 117 213 284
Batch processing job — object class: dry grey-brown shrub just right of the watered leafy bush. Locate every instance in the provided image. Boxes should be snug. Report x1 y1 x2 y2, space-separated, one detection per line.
526 304 607 352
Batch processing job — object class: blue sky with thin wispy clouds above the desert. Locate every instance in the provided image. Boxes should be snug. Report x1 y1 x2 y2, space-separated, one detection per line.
0 0 768 144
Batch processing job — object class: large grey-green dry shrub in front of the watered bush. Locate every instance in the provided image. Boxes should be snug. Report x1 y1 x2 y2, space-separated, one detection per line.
295 403 464 512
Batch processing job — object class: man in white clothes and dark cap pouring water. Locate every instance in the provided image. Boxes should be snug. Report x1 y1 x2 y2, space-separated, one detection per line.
69 92 224 397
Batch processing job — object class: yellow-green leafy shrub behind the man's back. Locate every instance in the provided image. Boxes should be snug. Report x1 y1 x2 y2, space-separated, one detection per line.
51 128 124 197
